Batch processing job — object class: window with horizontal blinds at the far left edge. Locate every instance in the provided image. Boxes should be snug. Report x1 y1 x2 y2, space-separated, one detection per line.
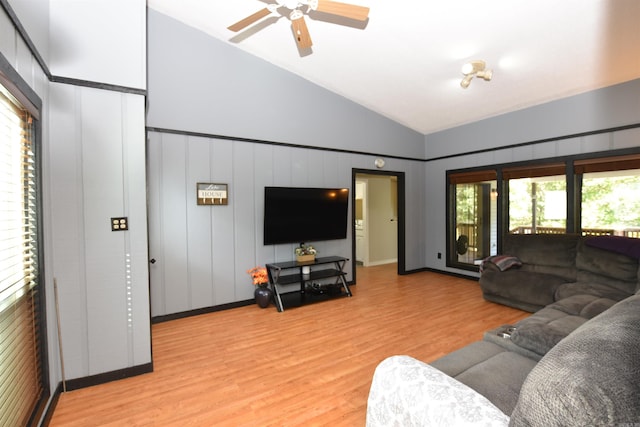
0 85 48 426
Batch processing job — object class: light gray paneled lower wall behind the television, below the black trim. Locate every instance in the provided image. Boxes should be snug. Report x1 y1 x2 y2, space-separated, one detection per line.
148 131 425 317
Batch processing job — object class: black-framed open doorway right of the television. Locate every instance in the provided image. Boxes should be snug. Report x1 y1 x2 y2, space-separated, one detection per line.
351 169 406 283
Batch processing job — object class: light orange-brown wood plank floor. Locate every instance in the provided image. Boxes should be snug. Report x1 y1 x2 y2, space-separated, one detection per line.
50 264 529 427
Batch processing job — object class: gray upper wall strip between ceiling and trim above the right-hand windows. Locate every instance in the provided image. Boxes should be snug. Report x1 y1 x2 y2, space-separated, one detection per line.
425 79 640 159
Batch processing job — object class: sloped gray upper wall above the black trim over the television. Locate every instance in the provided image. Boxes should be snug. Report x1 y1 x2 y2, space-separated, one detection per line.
147 9 425 159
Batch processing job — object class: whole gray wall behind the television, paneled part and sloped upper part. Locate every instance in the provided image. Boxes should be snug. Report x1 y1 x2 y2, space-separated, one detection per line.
147 10 426 316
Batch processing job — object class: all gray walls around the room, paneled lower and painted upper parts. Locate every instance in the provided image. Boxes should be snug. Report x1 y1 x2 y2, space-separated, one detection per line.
0 0 640 422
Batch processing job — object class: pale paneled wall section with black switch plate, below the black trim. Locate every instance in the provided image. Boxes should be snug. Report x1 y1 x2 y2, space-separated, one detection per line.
49 84 151 378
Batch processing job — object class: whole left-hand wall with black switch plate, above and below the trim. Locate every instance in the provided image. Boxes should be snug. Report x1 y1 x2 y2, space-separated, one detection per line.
0 0 151 420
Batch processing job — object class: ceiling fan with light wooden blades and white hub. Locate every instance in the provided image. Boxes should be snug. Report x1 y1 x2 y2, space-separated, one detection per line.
227 0 369 49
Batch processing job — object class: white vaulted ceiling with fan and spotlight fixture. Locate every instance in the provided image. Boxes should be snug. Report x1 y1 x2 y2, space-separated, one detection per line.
147 0 640 134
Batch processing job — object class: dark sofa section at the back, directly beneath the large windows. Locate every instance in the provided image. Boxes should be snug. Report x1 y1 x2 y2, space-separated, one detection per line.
480 234 640 312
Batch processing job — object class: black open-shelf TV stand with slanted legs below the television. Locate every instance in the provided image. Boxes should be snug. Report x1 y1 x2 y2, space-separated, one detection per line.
266 256 351 311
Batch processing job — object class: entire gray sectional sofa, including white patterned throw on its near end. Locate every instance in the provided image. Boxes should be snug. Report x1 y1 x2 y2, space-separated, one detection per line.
367 235 640 427
